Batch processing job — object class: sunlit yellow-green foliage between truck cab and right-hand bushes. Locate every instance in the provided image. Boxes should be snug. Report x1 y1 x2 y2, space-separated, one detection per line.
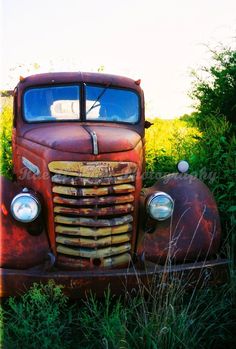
144 118 201 186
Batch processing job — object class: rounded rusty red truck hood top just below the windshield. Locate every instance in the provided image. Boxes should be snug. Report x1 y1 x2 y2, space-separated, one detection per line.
23 124 141 154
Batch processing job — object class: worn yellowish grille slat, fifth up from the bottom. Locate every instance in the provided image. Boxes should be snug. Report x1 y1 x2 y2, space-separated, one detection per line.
54 215 133 227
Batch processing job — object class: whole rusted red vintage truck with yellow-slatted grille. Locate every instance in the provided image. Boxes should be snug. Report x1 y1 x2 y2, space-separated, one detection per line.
1 72 227 297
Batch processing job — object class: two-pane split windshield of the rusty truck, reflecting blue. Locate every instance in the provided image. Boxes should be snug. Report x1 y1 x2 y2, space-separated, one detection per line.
23 85 140 123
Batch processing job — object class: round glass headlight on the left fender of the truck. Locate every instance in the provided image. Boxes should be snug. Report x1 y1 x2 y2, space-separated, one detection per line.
11 193 41 223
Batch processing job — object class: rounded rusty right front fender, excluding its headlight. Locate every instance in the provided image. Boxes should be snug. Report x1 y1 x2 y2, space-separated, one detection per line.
138 174 221 263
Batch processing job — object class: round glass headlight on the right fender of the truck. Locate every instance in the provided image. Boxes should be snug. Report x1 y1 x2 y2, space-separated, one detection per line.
147 192 174 221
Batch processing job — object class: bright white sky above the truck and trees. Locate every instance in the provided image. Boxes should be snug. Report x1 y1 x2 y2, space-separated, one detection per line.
0 0 236 118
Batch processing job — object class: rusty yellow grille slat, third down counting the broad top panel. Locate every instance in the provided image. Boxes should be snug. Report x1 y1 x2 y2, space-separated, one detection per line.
52 184 135 196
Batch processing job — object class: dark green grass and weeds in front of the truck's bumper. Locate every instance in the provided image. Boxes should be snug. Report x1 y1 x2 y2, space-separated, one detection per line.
1 277 236 349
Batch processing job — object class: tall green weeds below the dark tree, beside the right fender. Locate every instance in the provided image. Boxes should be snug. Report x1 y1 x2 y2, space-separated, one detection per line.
190 118 236 247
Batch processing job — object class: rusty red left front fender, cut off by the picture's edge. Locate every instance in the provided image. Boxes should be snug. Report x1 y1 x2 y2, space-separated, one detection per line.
0 176 50 269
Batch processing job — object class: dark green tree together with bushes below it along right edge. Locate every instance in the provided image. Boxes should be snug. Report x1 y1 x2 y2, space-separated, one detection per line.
188 48 236 253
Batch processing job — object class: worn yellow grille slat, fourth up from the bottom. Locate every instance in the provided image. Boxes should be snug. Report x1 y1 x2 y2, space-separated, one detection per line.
56 223 132 237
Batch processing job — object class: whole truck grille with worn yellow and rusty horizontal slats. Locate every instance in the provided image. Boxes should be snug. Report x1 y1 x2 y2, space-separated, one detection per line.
49 161 137 269
